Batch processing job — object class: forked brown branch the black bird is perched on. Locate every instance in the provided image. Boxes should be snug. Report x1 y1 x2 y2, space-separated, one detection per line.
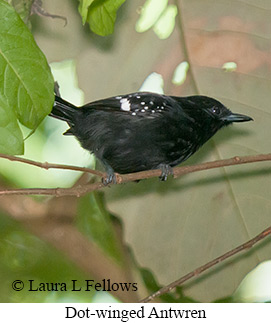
0 154 271 197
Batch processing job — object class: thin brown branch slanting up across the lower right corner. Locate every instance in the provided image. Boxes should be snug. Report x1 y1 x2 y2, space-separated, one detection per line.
140 227 271 303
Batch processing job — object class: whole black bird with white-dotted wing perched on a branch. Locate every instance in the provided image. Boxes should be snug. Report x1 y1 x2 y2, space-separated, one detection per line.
50 92 253 184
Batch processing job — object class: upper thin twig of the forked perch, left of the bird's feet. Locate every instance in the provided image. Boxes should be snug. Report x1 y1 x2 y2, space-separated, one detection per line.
0 154 105 177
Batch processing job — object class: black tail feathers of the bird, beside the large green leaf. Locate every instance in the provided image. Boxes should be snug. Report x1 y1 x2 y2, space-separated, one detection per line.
50 95 78 127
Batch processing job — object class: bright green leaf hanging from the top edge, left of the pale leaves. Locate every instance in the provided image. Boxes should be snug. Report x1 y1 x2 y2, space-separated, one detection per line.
86 0 126 36
